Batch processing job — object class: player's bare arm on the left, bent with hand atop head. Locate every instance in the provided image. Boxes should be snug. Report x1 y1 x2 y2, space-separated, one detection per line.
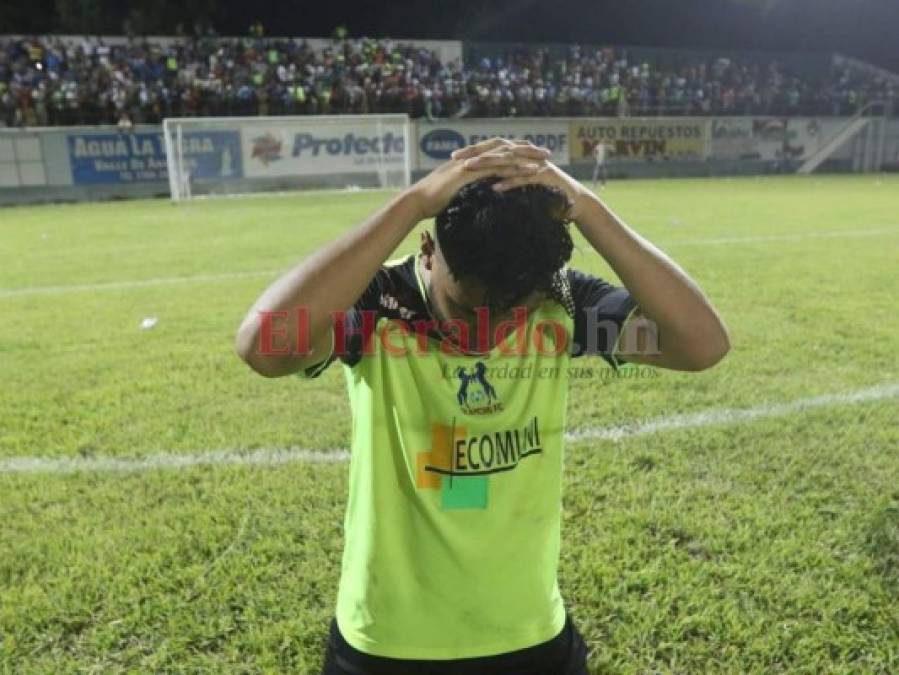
235 144 547 377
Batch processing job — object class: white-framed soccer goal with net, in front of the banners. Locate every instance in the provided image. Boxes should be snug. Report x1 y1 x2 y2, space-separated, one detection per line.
162 115 413 202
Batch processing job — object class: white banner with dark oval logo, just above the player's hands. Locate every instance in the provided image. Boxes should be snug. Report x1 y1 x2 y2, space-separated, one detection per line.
415 119 570 169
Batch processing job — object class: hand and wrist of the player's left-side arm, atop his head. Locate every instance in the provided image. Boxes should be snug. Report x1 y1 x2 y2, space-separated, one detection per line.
409 138 549 220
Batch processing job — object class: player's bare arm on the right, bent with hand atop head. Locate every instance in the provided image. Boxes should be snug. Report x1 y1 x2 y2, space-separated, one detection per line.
453 141 730 370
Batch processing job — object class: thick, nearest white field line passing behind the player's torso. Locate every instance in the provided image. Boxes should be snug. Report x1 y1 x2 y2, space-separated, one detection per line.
0 382 899 474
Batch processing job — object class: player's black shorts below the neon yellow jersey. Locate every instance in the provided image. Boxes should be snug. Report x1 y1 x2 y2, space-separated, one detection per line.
322 616 587 675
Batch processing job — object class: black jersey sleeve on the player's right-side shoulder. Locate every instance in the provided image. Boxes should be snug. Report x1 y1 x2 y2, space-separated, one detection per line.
568 269 637 367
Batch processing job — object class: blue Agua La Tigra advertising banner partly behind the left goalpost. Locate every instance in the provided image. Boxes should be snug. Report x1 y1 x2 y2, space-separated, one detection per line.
68 131 243 185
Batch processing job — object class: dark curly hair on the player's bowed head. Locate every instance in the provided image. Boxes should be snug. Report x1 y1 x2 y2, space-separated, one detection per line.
435 177 574 310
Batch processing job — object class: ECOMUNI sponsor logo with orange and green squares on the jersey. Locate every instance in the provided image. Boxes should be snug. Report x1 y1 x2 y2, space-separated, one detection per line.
416 415 543 509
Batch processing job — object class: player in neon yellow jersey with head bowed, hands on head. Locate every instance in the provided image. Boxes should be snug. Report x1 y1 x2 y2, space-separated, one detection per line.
236 139 729 675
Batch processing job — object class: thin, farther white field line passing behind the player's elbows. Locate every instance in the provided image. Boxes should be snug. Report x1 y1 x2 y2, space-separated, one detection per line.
0 227 899 300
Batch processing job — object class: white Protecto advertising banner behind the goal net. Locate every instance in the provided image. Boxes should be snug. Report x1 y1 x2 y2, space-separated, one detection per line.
240 117 404 178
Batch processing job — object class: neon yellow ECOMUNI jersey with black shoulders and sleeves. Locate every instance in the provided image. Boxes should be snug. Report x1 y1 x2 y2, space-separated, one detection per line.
305 256 634 659
